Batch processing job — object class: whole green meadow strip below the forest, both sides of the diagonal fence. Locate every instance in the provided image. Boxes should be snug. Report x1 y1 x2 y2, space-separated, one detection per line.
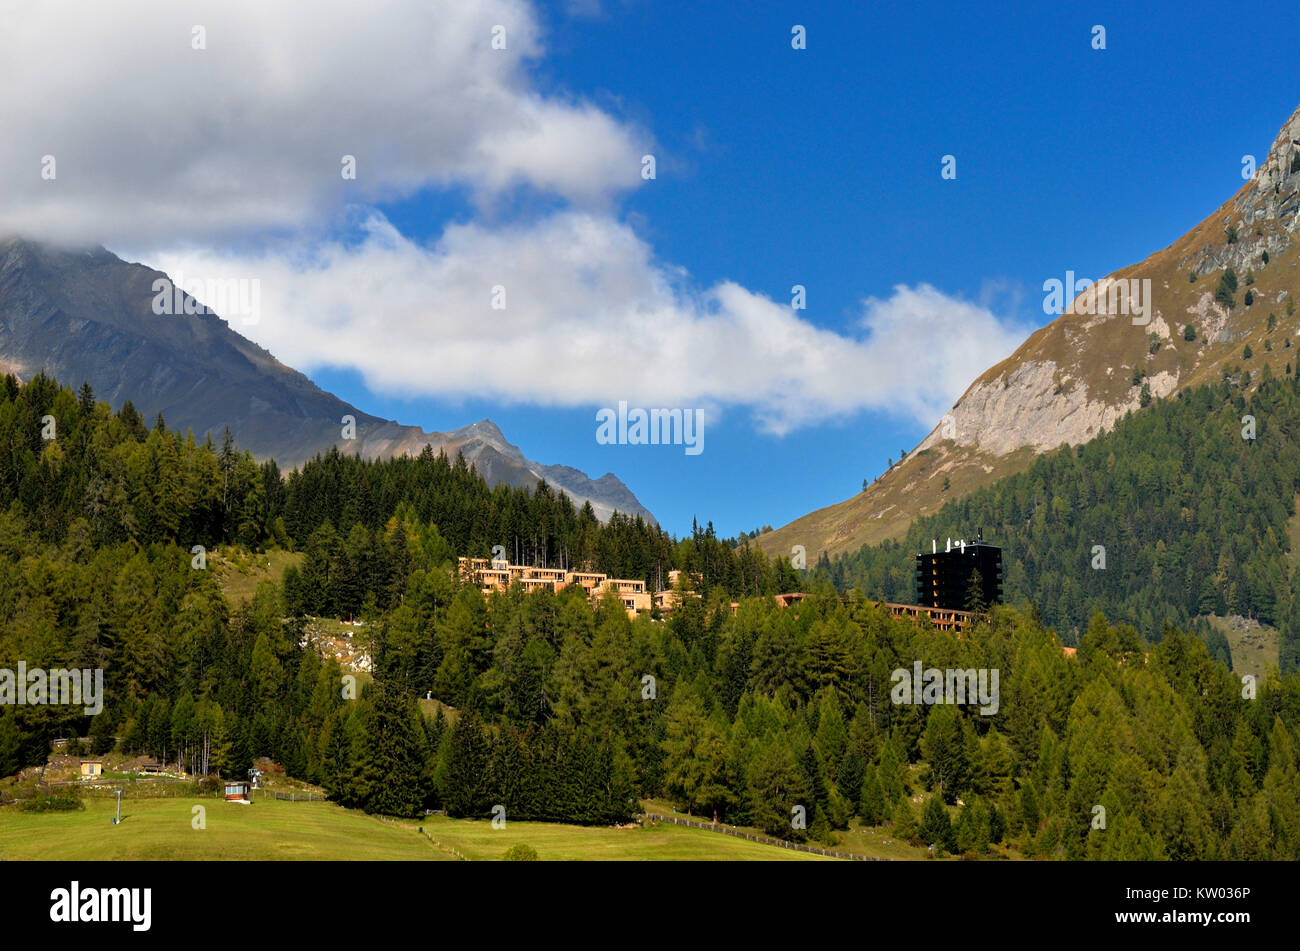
0 798 832 861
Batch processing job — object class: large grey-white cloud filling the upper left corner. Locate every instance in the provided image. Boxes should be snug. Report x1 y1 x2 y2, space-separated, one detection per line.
0 0 653 244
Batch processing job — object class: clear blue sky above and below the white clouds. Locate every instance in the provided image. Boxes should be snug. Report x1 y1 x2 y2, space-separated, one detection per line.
325 3 1300 535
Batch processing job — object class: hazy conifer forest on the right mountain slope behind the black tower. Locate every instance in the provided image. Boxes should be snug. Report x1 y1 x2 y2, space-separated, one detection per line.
816 368 1300 670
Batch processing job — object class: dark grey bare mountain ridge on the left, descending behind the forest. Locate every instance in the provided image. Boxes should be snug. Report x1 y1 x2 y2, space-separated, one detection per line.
0 238 654 521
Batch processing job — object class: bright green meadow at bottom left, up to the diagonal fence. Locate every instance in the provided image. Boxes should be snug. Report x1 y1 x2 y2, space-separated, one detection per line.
0 799 452 861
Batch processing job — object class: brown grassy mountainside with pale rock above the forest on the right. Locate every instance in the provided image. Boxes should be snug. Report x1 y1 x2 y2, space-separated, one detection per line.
757 100 1300 563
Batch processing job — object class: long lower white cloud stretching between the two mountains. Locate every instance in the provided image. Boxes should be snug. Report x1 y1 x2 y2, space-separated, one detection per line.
148 212 1023 434
